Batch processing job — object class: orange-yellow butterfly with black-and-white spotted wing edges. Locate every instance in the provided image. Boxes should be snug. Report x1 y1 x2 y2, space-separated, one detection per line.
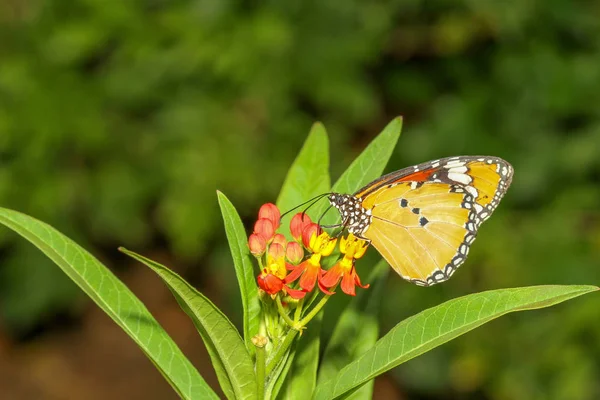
328 156 513 286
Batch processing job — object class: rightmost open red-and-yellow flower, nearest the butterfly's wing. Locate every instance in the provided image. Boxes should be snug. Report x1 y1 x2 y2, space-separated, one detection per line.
321 234 369 296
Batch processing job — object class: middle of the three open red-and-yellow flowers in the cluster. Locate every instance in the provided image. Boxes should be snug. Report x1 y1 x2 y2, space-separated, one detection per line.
285 231 337 294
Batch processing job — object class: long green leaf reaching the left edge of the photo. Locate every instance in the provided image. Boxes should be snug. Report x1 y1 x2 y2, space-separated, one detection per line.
0 208 218 399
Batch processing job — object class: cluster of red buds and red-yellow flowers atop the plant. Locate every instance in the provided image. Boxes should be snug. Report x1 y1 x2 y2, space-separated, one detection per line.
248 203 369 299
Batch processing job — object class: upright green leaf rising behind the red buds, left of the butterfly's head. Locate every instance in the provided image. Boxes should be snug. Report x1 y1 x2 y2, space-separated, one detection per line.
277 122 331 212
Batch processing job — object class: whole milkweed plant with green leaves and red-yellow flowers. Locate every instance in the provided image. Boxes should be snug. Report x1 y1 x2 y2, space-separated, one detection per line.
0 118 597 399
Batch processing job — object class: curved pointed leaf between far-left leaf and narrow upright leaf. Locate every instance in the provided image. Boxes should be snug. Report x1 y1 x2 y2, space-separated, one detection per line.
119 248 257 399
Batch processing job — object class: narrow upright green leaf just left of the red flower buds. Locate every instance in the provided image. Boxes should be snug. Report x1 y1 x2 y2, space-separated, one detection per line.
217 191 261 355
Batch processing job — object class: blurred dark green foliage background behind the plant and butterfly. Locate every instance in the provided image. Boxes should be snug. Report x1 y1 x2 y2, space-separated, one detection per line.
0 0 600 400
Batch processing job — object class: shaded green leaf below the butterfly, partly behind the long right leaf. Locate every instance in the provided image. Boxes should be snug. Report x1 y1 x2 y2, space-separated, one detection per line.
318 260 390 399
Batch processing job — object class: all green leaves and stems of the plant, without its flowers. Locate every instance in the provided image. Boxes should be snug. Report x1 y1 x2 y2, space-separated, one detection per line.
0 119 598 399
